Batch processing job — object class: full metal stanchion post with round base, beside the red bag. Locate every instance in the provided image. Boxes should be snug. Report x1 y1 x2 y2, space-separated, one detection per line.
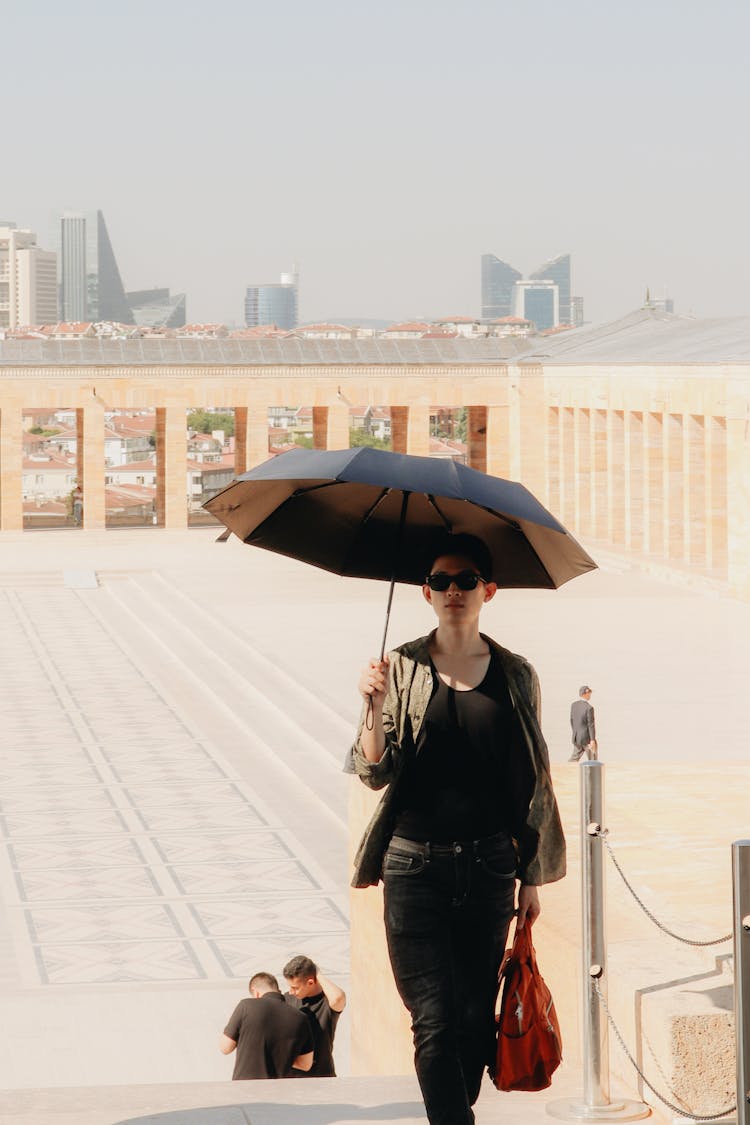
546 762 651 1122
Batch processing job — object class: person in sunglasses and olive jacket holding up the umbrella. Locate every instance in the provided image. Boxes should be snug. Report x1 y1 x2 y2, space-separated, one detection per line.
353 536 566 1125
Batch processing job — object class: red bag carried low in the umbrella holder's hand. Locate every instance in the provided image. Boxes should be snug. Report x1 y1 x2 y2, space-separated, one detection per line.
493 924 562 1090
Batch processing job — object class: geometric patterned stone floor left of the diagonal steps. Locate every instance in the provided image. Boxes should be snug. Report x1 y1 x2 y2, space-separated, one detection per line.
0 586 349 987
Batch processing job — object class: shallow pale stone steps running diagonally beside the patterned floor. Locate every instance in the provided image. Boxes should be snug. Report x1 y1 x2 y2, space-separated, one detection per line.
78 576 351 887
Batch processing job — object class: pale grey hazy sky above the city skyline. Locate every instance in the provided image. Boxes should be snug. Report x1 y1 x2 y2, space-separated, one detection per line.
5 0 750 323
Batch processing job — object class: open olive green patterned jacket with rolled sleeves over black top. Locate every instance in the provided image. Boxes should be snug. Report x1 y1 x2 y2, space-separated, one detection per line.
345 635 566 887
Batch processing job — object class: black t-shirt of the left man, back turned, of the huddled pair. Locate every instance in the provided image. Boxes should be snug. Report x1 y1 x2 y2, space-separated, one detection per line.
224 992 315 1079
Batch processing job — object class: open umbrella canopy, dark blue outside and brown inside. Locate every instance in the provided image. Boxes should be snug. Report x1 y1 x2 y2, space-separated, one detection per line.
204 447 596 590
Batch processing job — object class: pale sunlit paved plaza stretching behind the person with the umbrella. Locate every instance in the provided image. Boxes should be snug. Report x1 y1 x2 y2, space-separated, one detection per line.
0 529 750 1125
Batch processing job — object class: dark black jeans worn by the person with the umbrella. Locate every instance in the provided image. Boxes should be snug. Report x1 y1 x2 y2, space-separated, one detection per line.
383 834 516 1125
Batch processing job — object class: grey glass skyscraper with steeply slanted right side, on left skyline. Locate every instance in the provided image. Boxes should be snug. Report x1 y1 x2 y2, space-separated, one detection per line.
58 210 132 324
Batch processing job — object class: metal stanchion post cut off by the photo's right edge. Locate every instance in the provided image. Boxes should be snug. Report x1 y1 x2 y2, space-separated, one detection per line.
732 840 750 1125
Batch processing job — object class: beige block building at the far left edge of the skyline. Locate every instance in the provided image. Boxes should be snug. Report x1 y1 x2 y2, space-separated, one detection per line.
0 223 57 331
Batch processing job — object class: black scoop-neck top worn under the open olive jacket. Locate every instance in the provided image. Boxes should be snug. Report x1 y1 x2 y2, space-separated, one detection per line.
394 654 532 844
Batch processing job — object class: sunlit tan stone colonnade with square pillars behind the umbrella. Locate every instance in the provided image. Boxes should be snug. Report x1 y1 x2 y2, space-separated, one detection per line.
0 362 750 596
